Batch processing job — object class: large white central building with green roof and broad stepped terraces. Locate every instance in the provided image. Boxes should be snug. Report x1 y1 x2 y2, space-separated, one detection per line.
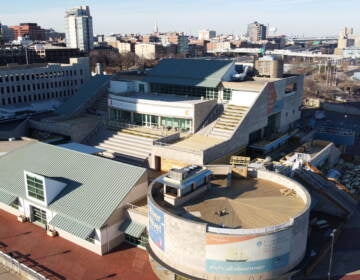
99 59 303 170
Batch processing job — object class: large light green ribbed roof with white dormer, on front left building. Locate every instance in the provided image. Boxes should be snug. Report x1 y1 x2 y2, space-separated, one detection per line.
0 142 146 229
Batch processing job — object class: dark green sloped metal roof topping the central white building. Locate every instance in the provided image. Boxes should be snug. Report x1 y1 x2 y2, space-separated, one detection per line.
144 59 234 88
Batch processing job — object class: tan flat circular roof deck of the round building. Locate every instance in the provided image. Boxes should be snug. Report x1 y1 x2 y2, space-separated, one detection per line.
154 178 305 229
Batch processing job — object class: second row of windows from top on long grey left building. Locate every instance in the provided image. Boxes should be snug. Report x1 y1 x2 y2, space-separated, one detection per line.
0 79 84 94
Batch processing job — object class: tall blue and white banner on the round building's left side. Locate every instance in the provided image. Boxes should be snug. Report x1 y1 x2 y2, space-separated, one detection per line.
148 201 165 251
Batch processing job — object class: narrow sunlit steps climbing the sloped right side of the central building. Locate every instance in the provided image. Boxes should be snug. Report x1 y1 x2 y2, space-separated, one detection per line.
208 104 249 139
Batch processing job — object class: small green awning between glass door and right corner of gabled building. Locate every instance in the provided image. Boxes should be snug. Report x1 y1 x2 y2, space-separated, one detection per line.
49 214 95 239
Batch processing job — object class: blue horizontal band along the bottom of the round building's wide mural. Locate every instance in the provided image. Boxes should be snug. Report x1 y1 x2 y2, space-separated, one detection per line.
206 253 289 275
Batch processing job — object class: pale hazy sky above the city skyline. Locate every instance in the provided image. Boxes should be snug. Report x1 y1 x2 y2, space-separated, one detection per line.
0 0 360 36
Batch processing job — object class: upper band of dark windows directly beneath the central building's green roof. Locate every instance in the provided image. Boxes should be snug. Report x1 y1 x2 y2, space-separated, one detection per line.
151 84 219 99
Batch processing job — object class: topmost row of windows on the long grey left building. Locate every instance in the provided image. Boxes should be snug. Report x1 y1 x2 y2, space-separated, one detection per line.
0 69 84 83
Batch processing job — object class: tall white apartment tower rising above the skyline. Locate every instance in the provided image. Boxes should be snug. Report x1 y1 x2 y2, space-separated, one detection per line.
65 6 94 52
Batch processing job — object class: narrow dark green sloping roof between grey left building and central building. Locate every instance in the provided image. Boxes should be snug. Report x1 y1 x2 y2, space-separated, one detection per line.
55 75 112 116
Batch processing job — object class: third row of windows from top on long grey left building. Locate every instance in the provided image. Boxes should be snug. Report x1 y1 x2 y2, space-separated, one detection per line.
1 89 75 105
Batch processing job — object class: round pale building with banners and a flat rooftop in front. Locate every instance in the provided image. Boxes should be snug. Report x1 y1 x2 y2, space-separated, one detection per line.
148 165 310 280
